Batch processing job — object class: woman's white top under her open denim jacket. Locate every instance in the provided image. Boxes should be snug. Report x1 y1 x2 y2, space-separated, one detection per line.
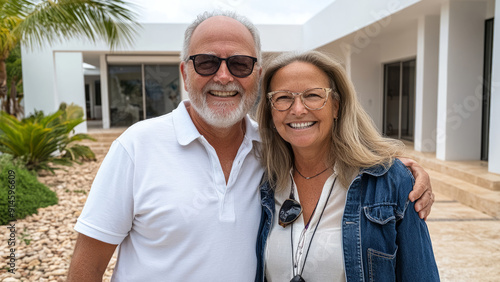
265 173 347 282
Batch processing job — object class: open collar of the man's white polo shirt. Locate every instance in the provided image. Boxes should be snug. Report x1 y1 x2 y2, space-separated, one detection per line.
172 100 260 146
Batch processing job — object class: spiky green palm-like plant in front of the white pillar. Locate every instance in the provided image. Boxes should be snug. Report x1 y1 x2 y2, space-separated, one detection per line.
0 104 95 172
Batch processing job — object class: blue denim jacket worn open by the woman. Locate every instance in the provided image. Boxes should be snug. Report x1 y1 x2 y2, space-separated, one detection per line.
255 159 439 281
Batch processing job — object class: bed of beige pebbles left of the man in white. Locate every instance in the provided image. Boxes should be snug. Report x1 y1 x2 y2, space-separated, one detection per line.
0 156 116 281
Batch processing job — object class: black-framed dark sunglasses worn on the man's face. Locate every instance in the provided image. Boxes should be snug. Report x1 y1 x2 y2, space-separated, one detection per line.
188 54 257 78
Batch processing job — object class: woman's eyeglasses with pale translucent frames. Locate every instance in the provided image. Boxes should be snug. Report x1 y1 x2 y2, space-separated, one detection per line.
271 88 328 111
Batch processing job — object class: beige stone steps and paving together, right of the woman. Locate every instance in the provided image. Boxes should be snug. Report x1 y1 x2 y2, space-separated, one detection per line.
406 143 500 281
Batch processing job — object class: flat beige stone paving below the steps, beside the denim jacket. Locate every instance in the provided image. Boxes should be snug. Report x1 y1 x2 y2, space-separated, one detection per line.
427 194 500 281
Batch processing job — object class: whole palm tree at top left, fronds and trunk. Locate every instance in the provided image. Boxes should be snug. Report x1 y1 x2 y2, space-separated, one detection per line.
0 0 139 115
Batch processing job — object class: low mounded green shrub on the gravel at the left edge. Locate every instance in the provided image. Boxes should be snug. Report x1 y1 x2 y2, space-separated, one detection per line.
0 154 58 225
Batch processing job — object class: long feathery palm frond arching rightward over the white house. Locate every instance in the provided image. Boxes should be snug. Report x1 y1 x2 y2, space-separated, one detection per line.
13 0 139 49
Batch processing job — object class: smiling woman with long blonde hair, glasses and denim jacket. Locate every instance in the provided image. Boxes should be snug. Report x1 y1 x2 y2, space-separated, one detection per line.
257 51 439 281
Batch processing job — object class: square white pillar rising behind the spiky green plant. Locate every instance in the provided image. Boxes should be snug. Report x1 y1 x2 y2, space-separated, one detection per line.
54 52 87 133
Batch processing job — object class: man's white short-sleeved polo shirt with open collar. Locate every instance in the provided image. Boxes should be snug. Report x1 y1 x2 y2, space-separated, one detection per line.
75 102 263 282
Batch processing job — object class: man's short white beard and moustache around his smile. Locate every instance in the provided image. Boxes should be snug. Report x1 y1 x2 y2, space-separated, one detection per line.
186 78 258 128
